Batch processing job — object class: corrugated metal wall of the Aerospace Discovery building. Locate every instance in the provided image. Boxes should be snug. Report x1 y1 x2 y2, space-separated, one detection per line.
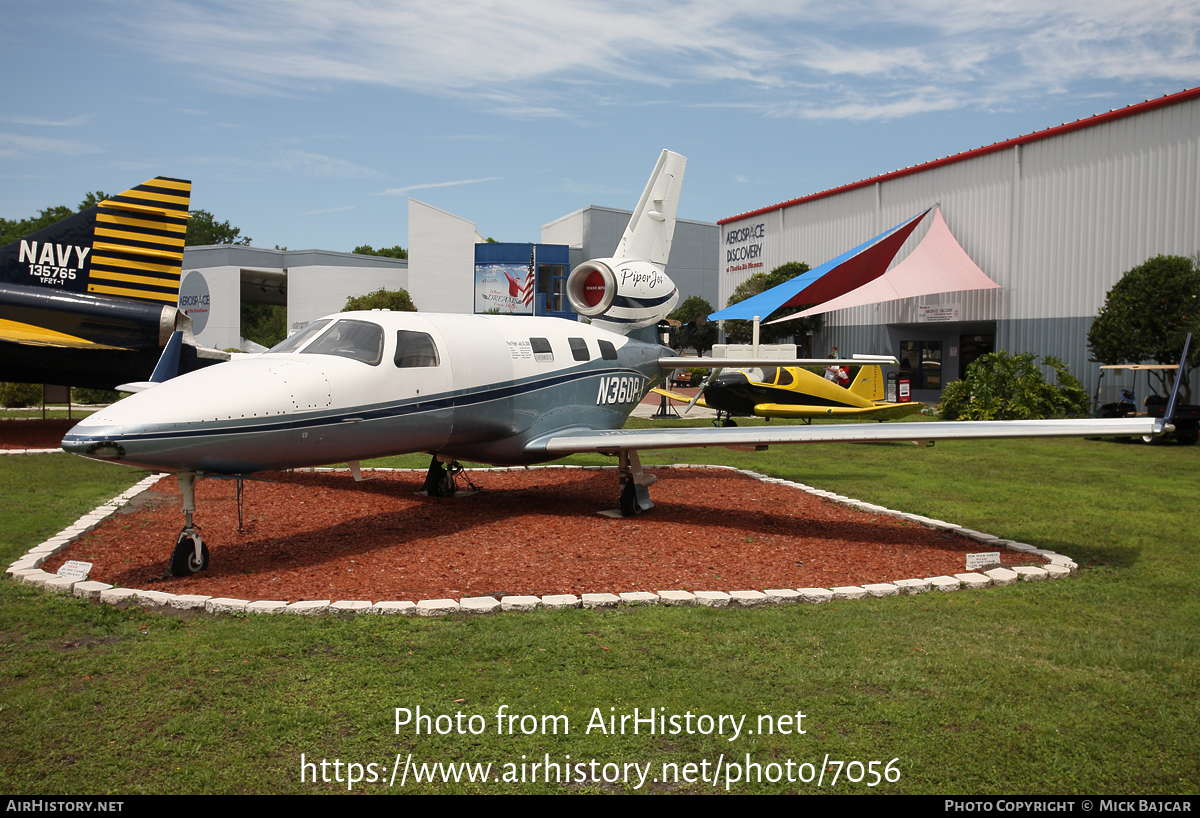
720 92 1200 391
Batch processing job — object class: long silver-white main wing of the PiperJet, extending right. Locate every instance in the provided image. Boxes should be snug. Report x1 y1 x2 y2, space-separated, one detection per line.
526 417 1156 455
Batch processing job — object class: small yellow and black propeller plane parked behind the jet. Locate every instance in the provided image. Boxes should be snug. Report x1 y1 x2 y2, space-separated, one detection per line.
653 359 925 426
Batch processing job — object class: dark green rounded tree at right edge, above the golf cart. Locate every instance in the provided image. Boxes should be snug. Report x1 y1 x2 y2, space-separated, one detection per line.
1087 255 1200 403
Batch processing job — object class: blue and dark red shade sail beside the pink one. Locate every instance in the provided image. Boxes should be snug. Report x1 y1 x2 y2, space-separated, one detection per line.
708 210 929 323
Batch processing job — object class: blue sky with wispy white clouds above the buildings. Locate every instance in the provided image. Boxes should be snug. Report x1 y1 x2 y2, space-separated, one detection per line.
0 0 1200 251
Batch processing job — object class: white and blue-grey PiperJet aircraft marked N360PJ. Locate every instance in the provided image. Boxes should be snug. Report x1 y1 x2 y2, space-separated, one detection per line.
62 151 1170 576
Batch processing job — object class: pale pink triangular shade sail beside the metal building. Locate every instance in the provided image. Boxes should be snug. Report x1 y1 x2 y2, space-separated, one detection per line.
769 209 1000 324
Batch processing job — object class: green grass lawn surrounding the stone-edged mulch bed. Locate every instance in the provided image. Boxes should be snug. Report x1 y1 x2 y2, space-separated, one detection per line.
0 440 1200 794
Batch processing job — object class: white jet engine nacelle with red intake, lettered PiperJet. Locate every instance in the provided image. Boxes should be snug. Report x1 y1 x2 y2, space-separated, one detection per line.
566 258 679 333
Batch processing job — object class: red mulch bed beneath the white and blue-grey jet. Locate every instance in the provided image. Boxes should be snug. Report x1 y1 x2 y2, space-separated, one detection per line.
43 469 1040 601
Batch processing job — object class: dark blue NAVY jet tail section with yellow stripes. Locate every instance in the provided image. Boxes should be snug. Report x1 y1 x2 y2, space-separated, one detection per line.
0 176 229 389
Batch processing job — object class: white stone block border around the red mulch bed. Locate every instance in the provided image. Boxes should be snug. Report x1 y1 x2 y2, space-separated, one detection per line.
6 462 1079 616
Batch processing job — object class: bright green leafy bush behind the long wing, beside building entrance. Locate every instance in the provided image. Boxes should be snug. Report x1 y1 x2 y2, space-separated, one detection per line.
938 349 1087 420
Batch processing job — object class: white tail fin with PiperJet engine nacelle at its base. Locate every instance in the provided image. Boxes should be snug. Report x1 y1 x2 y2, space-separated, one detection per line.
566 150 688 335
